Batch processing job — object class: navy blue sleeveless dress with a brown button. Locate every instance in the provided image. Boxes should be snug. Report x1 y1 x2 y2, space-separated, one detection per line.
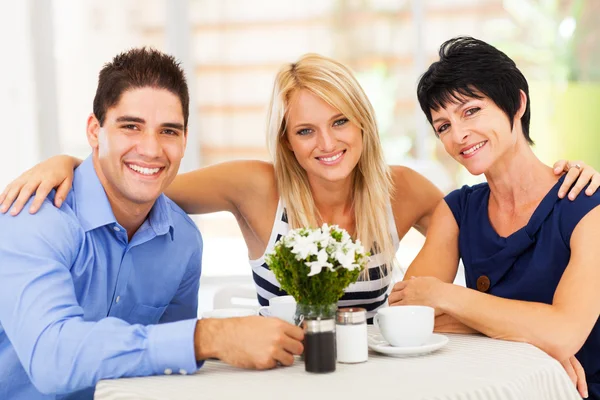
445 177 600 400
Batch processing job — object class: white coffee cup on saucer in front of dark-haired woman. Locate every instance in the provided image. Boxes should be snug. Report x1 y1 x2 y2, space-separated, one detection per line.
373 306 435 347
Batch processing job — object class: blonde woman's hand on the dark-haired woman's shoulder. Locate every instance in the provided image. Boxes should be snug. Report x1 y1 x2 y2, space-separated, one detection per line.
553 160 600 200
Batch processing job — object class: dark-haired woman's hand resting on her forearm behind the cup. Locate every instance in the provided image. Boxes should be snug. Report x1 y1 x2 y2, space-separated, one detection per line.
388 276 448 308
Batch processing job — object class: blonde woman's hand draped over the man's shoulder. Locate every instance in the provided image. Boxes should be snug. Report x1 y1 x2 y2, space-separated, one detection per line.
0 156 81 215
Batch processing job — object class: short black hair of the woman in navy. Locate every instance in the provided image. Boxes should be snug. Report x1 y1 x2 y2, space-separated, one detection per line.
417 36 533 144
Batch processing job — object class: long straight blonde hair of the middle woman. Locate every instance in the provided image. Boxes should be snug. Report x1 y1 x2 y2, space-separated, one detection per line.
267 54 395 272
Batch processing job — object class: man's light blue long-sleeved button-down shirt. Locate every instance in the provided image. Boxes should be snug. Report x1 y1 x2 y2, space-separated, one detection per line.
0 157 202 400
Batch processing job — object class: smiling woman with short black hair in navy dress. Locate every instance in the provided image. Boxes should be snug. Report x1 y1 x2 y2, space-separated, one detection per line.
390 37 600 399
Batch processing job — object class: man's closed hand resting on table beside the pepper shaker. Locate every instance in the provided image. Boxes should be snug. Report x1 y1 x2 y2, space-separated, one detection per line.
194 317 304 369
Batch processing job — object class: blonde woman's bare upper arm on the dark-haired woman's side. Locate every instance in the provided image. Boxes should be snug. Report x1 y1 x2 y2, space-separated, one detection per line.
390 165 444 235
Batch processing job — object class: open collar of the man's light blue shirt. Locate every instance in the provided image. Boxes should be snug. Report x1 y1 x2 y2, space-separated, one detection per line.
73 156 174 240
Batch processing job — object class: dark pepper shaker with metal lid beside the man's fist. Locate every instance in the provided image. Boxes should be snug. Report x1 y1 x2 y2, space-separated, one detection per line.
302 318 335 373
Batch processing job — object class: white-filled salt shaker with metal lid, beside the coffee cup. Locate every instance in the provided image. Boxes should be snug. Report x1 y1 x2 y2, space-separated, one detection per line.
335 308 369 364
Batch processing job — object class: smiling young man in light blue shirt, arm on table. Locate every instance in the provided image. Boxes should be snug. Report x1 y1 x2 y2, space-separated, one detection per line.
0 49 303 400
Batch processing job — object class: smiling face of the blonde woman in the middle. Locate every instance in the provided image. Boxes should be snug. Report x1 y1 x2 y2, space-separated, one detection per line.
286 90 363 182
